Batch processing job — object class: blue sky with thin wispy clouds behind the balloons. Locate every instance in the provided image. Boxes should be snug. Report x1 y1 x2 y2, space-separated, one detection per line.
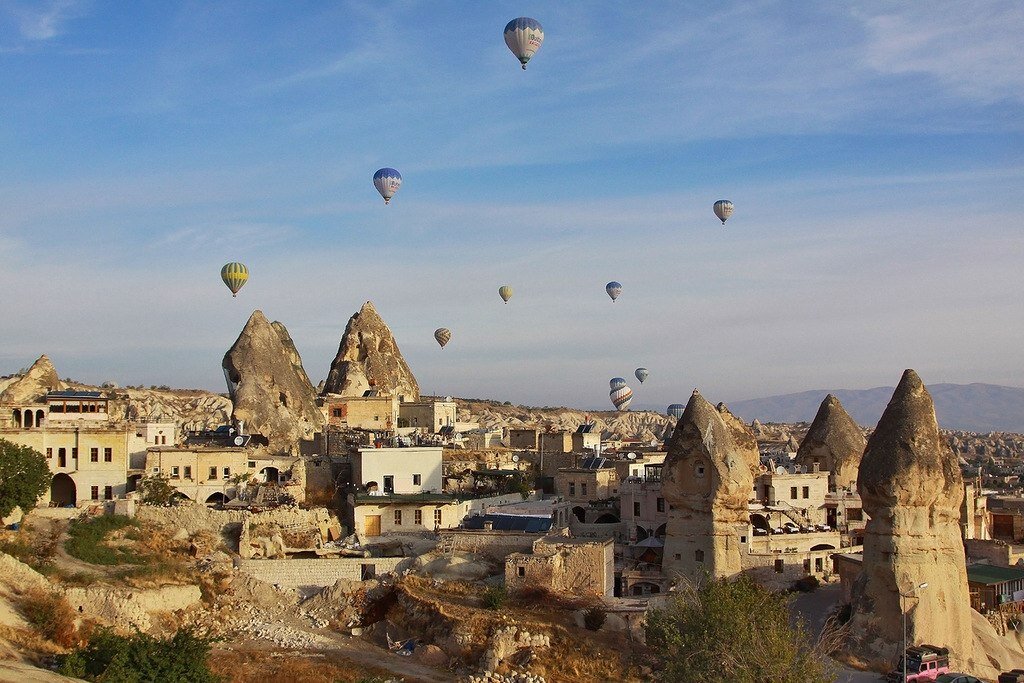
0 0 1024 411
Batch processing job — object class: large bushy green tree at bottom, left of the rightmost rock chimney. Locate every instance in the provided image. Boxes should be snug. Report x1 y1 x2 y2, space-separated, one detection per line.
646 577 836 683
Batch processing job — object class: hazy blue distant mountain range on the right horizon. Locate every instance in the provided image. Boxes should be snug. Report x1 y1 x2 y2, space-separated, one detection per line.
729 384 1024 432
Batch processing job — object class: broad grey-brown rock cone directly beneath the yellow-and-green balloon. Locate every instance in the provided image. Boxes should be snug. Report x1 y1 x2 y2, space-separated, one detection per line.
222 310 324 453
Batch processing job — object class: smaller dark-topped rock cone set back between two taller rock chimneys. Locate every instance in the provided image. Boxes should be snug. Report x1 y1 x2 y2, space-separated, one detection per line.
797 394 866 490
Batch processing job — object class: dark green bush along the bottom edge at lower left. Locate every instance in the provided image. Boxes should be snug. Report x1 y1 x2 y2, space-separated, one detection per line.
57 629 221 683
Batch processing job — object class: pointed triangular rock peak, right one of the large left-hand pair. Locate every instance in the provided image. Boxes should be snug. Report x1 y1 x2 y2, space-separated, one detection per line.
323 301 420 400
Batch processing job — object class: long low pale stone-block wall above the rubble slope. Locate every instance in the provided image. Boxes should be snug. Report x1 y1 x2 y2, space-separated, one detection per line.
239 557 413 590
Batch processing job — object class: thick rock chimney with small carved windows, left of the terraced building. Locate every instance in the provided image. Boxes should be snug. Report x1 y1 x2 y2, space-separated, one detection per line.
662 391 754 579
